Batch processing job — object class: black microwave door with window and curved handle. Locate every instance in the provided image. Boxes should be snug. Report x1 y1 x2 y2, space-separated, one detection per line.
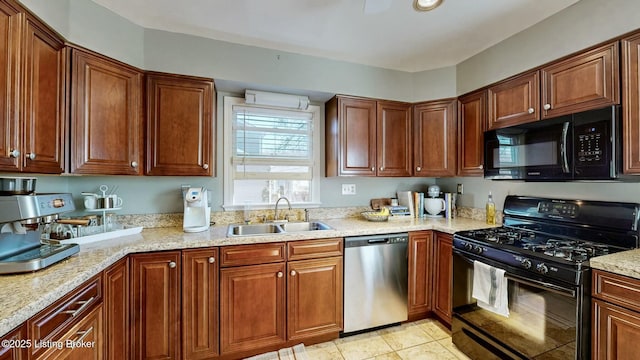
484 116 573 180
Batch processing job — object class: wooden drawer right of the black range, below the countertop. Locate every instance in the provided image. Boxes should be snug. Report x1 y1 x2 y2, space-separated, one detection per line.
592 270 640 311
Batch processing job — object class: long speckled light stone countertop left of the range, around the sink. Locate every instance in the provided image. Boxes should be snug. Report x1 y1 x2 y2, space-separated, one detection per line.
0 218 496 336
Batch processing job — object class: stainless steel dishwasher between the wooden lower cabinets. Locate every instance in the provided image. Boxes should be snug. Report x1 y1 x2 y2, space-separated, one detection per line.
343 233 409 334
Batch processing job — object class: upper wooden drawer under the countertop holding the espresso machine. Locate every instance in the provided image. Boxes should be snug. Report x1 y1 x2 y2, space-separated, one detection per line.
27 274 102 355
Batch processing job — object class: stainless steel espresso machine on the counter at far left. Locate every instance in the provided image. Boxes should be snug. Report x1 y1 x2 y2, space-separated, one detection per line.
0 193 80 274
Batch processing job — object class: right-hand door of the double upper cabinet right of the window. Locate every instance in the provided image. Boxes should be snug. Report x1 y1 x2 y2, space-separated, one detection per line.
376 101 413 177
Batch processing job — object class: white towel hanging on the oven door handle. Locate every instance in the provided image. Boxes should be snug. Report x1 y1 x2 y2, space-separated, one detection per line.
471 261 509 317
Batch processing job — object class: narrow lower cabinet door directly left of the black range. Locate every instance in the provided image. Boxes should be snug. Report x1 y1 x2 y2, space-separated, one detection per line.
433 232 453 325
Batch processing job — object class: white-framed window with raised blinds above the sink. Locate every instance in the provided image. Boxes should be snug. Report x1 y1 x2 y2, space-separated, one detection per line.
224 96 320 210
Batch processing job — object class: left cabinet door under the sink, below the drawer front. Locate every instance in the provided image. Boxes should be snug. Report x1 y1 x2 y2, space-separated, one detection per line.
220 263 286 354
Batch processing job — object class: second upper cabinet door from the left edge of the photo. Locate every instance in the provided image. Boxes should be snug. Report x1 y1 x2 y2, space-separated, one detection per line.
20 16 67 174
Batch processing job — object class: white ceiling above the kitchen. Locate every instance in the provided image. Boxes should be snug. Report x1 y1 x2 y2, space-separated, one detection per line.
93 0 578 72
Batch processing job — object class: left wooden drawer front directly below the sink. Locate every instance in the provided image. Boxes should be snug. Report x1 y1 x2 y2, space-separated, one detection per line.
220 243 286 267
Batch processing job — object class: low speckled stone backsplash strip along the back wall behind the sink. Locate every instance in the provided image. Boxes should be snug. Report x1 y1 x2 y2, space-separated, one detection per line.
117 206 502 229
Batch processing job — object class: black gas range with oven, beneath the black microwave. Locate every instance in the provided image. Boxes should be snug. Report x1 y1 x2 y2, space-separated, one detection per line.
452 196 640 359
